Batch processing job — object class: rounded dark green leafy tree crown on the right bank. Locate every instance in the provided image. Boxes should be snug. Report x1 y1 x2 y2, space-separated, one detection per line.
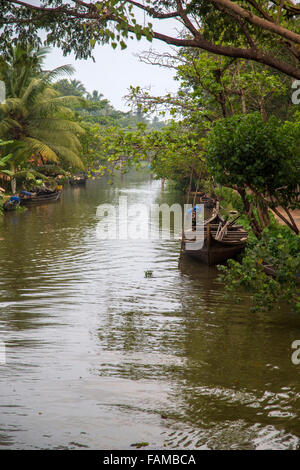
207 113 300 208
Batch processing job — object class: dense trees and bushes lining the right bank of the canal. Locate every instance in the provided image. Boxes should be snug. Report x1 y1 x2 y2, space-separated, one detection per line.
89 46 300 309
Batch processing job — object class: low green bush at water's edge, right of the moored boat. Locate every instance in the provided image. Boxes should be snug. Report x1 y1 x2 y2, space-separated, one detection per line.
219 225 300 313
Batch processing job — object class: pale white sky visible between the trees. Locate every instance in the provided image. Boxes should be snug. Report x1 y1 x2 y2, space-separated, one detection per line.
40 0 178 111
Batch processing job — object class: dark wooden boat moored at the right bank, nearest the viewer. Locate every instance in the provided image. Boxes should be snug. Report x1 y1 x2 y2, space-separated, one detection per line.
182 212 248 266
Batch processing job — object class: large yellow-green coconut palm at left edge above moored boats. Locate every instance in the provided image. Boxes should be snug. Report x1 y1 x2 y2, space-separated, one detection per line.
0 51 84 190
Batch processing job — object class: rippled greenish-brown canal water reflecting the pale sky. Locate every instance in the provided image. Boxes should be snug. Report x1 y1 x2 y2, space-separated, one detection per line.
0 173 300 449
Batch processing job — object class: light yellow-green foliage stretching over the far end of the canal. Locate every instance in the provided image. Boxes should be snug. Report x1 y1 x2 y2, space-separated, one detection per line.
86 118 207 188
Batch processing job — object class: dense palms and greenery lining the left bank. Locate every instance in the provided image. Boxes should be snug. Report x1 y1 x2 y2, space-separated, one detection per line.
0 45 157 197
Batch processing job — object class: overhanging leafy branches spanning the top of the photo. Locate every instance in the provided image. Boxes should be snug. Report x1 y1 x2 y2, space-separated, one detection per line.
0 0 300 79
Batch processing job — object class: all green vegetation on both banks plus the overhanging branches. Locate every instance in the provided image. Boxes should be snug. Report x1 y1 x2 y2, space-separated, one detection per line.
0 0 300 309
